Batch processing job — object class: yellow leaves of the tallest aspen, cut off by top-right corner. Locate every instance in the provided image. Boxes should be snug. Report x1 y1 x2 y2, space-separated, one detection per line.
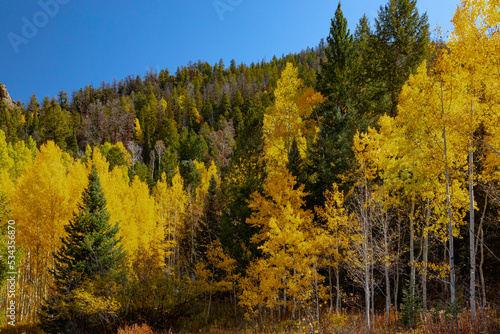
447 0 500 182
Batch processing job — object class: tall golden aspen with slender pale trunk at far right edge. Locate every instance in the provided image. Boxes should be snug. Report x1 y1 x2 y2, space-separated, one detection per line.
447 0 500 317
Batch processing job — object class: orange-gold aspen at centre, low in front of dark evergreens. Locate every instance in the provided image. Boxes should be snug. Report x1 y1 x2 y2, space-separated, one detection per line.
240 169 326 328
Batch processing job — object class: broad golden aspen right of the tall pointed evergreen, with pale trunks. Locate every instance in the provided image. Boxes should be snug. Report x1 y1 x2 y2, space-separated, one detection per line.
357 58 468 328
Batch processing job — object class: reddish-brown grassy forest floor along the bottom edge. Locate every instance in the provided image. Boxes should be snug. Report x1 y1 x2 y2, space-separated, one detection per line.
0 309 500 334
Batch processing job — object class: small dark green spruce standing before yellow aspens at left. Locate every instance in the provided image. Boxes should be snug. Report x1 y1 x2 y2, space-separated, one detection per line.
39 165 125 333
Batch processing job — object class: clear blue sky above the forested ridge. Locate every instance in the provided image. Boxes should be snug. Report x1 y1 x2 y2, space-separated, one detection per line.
0 0 458 102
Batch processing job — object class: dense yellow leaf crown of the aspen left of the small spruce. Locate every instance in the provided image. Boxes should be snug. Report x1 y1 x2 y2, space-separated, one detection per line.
12 141 87 251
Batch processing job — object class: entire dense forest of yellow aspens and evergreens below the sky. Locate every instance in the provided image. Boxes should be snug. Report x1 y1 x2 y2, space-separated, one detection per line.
0 0 500 333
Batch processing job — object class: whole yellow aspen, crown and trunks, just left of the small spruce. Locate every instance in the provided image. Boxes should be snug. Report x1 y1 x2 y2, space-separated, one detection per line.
11 141 87 321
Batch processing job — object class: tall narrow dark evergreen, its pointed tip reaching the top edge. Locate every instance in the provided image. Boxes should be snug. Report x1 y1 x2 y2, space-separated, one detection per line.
306 2 356 208
